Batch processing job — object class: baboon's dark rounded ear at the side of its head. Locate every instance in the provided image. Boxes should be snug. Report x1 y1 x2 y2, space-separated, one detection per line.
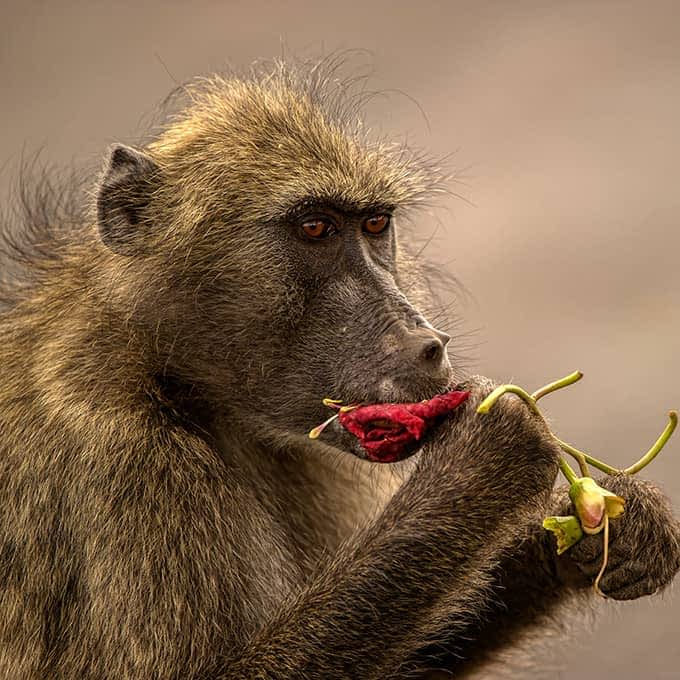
97 144 158 255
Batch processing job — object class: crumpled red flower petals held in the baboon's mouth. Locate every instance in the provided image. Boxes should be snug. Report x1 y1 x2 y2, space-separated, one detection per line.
338 390 470 463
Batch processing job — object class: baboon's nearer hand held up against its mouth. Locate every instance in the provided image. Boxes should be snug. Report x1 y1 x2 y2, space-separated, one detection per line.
420 376 560 507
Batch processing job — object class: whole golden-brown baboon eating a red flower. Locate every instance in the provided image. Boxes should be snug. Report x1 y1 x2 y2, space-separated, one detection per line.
0 63 680 680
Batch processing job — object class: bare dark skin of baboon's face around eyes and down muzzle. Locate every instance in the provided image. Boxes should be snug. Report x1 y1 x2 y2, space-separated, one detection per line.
234 194 452 448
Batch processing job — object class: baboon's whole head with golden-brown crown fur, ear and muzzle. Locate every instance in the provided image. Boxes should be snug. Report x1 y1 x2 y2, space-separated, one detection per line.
97 63 450 460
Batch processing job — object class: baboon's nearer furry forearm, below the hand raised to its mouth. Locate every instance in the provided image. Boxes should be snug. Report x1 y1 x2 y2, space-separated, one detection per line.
219 464 544 679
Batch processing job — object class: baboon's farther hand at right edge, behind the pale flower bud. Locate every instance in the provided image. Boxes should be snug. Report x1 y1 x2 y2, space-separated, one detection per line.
551 475 680 600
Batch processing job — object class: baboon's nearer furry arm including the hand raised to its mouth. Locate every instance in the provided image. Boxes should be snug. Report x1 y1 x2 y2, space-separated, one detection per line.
217 390 557 680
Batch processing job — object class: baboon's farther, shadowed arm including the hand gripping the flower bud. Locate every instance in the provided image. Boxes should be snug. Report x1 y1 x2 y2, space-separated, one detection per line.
412 476 680 675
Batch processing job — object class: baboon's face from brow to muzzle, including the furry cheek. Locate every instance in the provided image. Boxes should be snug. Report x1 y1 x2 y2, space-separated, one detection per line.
203 202 450 455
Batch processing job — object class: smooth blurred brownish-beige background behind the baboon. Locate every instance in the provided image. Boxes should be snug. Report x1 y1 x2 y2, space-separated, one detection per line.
0 0 680 680
